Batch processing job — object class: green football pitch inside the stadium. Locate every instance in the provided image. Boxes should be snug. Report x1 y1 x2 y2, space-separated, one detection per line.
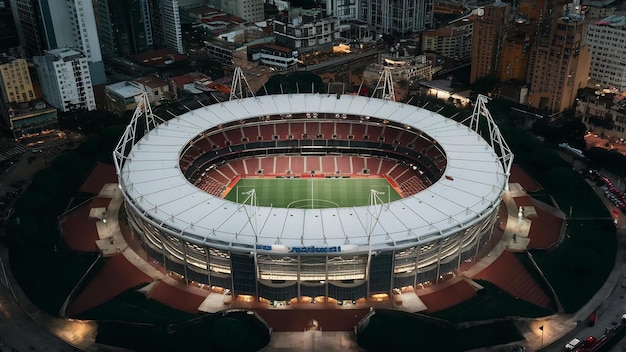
225 178 402 209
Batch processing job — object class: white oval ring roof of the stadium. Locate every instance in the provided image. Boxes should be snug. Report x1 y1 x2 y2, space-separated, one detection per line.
117 94 507 252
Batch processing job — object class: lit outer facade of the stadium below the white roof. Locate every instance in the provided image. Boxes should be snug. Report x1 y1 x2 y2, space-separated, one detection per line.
127 207 498 301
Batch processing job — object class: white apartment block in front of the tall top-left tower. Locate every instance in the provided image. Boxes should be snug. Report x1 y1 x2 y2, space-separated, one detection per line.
33 48 96 111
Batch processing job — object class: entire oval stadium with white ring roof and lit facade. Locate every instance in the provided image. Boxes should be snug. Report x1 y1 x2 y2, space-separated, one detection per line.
114 72 513 302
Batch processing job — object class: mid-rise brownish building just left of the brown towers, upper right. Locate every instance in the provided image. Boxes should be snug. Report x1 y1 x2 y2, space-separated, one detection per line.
422 20 474 61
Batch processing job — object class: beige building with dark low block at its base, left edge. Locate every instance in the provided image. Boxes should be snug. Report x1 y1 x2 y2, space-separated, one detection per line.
0 56 59 139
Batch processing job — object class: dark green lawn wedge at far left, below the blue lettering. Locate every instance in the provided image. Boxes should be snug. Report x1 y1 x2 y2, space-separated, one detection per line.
9 246 97 316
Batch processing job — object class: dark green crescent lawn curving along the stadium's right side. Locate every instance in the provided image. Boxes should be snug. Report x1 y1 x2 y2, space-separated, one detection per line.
503 123 617 312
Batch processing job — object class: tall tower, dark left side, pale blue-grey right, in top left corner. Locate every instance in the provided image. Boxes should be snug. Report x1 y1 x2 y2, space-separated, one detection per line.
11 0 106 84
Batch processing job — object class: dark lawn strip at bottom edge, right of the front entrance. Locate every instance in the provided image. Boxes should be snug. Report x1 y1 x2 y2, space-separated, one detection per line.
357 309 524 352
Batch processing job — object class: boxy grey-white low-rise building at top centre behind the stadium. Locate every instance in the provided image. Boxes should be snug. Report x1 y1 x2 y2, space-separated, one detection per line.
272 9 340 53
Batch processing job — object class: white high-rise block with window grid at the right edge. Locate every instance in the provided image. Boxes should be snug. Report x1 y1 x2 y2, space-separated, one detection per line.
587 15 626 92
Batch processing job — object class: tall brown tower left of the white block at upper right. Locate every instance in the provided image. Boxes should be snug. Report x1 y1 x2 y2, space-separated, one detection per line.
527 6 591 113
